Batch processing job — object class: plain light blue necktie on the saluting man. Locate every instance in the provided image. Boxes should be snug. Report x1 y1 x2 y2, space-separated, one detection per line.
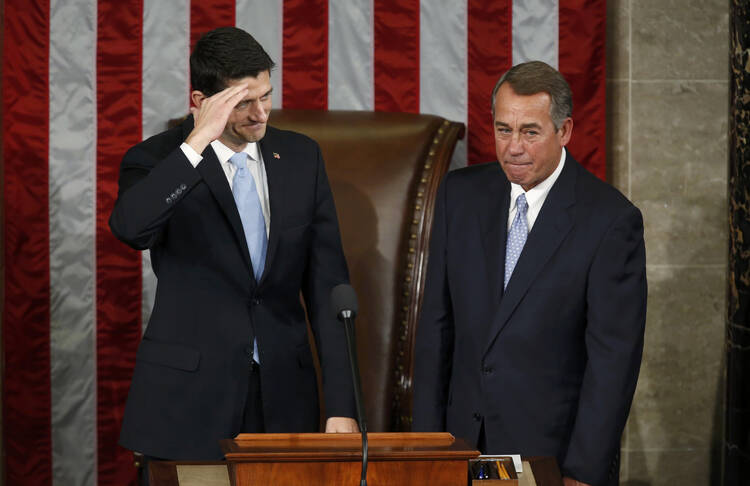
229 152 268 281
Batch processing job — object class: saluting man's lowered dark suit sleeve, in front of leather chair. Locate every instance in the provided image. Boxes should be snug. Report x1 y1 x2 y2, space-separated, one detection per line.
302 144 356 417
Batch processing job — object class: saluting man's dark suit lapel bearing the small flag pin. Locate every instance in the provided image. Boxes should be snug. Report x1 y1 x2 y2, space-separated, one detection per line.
258 127 286 282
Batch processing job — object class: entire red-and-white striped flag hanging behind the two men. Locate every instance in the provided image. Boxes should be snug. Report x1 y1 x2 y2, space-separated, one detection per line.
2 0 606 486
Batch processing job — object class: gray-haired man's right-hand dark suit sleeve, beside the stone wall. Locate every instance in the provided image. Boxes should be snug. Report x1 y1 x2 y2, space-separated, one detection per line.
562 206 647 484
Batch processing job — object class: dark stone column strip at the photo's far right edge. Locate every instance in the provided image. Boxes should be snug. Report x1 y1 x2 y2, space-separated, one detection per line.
723 0 750 486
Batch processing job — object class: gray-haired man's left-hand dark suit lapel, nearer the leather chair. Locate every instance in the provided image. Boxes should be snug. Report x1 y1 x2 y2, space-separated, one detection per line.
477 169 510 305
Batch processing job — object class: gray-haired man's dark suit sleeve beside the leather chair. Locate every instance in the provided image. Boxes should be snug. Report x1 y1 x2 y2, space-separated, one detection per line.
412 179 454 431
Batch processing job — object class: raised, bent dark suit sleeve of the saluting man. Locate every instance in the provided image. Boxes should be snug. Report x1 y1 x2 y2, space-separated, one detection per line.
109 145 200 250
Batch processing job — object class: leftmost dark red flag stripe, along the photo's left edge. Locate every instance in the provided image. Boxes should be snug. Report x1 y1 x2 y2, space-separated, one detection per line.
3 2 51 484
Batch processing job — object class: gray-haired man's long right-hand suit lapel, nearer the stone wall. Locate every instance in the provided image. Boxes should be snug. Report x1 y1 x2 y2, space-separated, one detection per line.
485 156 577 352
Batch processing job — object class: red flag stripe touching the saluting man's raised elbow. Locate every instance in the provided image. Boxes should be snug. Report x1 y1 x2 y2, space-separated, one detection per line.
95 2 143 484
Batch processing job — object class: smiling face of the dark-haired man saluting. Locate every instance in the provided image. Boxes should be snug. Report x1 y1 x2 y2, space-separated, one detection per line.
219 71 271 149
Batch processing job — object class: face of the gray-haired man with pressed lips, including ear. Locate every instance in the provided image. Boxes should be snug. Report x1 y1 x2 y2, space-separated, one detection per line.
494 83 573 191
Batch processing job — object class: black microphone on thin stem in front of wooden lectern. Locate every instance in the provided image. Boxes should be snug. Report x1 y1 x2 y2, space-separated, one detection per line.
331 284 367 486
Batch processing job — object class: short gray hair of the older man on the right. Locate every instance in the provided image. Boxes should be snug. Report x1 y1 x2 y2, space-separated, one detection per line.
492 61 573 130
